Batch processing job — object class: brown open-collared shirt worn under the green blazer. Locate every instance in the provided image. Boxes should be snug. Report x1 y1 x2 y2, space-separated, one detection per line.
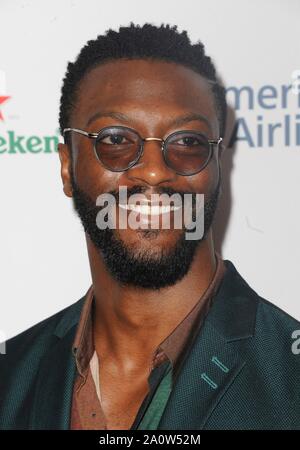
70 254 225 430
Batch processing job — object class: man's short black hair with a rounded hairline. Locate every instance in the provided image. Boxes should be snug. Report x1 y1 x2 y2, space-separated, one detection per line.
59 22 227 136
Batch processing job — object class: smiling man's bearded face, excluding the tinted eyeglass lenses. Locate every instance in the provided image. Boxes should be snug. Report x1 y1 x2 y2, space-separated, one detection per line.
59 60 220 289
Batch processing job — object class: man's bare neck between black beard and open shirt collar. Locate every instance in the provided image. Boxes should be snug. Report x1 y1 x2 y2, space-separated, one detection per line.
86 230 216 366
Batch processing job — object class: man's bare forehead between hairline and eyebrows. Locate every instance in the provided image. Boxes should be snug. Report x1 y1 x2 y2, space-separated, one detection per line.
71 59 218 130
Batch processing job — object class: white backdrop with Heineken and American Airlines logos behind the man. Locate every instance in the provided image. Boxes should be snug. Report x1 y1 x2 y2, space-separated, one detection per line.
0 0 300 341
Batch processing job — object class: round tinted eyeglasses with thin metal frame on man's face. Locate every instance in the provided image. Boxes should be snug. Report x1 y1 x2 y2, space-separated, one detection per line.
63 125 222 176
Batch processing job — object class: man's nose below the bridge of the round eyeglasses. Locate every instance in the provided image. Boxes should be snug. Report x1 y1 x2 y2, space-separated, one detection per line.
127 138 177 186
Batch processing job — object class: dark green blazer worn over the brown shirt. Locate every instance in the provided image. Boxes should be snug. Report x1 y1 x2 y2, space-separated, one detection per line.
0 260 300 430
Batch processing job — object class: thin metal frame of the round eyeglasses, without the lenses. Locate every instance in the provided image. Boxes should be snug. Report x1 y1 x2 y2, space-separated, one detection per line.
63 125 223 176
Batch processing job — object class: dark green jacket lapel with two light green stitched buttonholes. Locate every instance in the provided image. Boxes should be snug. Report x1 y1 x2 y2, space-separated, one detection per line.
158 261 258 430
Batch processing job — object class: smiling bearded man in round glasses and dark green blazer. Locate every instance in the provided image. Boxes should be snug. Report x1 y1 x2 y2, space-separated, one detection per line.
0 23 300 430
